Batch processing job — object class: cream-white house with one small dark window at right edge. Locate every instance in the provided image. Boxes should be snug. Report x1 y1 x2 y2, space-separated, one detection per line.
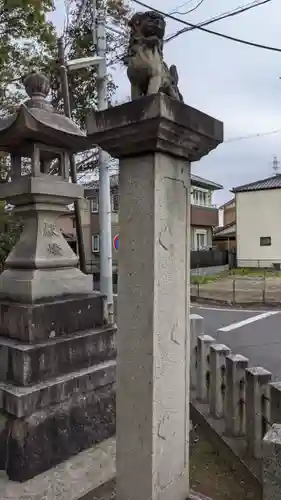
233 175 281 267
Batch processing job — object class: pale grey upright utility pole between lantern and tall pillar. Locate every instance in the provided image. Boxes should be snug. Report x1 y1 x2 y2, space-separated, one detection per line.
92 0 114 322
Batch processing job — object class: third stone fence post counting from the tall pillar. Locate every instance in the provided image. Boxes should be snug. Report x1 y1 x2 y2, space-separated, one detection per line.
210 344 230 418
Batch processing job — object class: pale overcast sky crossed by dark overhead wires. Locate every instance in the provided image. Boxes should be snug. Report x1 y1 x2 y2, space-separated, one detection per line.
49 0 281 203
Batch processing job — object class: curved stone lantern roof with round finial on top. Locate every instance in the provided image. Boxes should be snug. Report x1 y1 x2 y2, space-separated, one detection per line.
0 71 90 156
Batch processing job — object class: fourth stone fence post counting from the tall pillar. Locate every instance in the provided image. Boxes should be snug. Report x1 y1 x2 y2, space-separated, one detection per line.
225 354 249 436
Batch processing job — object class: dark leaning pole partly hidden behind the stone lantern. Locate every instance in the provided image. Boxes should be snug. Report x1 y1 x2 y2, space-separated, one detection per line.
58 38 86 273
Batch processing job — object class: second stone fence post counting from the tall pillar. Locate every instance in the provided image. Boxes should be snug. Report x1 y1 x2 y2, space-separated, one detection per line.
196 335 215 403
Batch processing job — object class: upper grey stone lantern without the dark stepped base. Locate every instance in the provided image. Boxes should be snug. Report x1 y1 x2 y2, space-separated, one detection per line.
0 72 92 303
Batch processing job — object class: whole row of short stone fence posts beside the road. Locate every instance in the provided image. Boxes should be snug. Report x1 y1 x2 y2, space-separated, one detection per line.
190 314 281 500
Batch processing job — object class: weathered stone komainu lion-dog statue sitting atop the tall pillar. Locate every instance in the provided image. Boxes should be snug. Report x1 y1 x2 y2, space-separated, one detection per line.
124 11 183 101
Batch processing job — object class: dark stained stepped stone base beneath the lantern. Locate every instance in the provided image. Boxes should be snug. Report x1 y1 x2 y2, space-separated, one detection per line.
0 294 116 482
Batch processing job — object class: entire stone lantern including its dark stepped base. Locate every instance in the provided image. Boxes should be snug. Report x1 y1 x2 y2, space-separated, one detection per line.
0 73 116 482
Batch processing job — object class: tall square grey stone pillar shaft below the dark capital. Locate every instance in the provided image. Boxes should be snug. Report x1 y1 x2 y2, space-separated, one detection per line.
116 146 190 500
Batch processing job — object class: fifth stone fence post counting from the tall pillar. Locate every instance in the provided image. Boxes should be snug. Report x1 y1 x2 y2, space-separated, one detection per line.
246 366 272 459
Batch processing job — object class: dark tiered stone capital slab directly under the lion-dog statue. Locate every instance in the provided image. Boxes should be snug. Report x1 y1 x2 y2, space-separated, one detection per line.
87 94 223 161
